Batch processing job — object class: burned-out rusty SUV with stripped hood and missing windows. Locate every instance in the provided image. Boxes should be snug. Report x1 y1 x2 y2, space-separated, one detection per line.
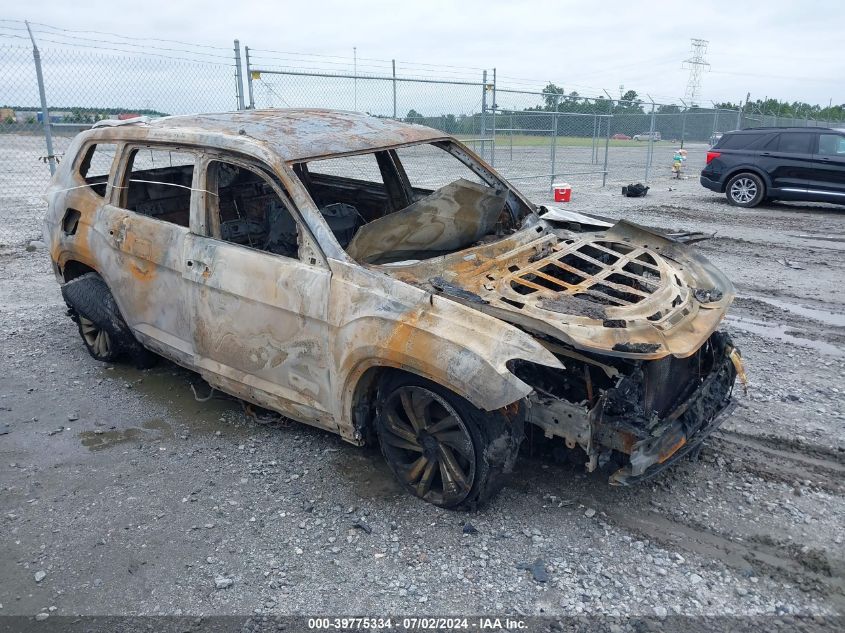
46 110 740 508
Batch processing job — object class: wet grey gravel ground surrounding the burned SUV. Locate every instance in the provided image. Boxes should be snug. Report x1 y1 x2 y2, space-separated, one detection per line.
0 136 845 628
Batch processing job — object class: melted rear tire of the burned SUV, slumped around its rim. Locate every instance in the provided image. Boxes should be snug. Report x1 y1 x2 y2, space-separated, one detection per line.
62 273 157 369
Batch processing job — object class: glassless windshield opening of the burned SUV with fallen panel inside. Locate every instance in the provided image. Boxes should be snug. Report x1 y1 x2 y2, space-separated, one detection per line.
293 142 532 264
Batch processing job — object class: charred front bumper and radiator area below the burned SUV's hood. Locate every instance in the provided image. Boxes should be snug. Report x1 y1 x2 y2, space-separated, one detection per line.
529 332 741 485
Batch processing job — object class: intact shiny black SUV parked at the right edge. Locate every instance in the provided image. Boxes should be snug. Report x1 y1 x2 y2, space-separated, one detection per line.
701 127 845 207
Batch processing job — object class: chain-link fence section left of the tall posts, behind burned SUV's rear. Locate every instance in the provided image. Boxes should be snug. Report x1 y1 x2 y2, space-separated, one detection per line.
0 20 238 244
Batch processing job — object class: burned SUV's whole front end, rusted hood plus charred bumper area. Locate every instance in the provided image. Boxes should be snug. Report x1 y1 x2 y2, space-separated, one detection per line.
372 213 744 485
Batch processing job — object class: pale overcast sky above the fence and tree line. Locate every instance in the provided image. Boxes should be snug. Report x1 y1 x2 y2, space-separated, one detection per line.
0 0 845 107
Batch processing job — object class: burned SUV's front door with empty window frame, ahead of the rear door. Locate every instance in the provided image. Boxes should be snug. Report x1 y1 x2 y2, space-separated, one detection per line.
184 149 338 432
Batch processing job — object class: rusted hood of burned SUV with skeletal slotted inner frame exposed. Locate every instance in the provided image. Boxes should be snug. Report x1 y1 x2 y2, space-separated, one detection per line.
380 220 734 358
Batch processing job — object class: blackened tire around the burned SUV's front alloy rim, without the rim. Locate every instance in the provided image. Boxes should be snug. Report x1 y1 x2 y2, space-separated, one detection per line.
374 374 526 510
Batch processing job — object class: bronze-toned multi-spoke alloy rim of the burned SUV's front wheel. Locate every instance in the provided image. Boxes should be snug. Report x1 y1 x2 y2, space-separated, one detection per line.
382 386 475 505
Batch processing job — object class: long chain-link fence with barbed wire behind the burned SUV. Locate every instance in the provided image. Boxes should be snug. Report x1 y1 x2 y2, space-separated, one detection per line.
0 20 843 244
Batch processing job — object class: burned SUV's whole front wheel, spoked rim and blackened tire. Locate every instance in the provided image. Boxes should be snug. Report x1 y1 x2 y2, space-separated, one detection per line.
375 375 524 509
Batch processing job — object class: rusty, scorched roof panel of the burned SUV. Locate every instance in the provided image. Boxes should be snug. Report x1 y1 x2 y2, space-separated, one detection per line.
137 109 449 161
